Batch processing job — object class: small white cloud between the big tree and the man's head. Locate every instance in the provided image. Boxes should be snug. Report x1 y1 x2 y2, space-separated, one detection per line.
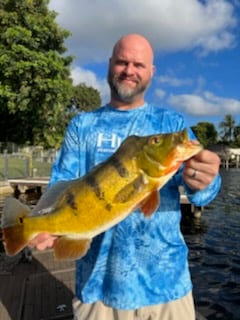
71 67 109 104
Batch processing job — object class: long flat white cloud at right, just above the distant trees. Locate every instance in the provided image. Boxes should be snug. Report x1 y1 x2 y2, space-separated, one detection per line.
168 91 240 116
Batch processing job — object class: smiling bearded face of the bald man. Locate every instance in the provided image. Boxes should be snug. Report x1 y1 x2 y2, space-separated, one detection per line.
108 45 153 103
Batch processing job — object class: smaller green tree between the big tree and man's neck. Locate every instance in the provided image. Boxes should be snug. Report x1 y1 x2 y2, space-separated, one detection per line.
72 83 101 111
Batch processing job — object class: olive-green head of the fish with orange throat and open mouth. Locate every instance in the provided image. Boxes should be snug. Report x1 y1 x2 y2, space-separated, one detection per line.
136 129 202 177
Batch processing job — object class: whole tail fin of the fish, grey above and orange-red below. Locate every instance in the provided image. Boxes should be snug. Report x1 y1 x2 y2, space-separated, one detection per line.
2 198 30 256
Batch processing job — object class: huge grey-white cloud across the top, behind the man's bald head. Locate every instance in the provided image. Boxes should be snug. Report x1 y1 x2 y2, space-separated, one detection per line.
49 0 236 63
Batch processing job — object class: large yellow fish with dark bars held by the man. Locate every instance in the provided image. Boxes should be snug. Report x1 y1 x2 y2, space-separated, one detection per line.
2 129 202 260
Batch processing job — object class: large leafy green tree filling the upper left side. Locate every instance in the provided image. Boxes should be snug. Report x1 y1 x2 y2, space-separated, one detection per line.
0 0 73 147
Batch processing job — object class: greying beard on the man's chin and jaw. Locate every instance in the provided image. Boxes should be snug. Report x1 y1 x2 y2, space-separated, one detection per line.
108 70 150 103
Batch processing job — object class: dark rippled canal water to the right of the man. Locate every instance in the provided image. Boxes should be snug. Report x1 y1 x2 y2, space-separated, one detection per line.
0 169 240 320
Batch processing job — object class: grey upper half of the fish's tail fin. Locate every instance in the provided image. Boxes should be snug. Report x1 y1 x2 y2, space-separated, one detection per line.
2 197 30 228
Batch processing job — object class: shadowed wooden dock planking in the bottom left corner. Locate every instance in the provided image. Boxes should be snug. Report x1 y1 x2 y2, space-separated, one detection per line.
0 250 75 320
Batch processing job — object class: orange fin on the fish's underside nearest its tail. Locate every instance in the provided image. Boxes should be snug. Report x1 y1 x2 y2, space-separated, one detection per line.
54 237 92 260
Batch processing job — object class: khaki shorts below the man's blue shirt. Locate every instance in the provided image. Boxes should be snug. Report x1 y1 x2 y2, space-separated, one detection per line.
73 292 195 320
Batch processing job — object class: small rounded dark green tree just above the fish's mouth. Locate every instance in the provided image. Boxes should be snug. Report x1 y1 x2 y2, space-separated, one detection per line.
191 122 218 147
